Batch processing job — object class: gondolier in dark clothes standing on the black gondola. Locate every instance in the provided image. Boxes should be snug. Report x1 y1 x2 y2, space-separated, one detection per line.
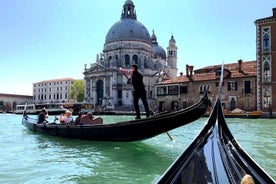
131 64 150 119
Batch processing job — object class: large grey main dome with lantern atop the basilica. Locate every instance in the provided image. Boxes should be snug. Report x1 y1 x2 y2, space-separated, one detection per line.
105 0 151 43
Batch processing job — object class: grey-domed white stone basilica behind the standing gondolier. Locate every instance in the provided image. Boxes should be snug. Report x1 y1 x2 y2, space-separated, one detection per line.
83 0 177 107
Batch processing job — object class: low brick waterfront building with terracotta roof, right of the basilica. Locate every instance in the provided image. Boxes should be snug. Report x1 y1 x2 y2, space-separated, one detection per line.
155 60 257 111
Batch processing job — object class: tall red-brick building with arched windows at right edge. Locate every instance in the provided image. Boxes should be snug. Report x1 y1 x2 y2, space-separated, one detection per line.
255 8 276 116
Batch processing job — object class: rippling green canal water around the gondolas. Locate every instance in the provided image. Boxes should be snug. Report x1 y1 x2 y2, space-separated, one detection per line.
0 114 276 184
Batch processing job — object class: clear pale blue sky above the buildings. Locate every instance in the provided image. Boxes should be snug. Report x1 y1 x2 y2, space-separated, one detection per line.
0 0 276 95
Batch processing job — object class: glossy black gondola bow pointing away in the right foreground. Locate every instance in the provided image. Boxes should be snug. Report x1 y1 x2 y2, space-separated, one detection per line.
157 98 275 184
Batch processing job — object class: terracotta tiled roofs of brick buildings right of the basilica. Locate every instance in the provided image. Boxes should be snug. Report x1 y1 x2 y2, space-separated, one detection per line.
159 61 257 84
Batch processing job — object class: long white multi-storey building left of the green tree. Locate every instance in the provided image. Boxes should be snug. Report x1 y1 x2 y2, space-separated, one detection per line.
33 78 75 104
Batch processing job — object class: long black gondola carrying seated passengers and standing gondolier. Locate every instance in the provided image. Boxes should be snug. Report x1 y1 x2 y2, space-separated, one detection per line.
22 94 209 142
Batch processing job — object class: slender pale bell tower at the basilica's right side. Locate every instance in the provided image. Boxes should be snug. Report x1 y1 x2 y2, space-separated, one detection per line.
167 35 177 77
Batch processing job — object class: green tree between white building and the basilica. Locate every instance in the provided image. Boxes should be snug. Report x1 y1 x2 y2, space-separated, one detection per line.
69 79 84 102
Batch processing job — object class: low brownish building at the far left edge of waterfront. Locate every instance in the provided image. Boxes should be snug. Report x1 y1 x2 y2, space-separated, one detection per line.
0 93 33 112
